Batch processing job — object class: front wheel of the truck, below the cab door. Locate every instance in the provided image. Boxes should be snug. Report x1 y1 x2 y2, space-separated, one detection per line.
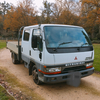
32 65 42 85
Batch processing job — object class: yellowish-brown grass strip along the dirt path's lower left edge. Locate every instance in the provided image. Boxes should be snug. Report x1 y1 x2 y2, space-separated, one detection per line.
0 67 44 100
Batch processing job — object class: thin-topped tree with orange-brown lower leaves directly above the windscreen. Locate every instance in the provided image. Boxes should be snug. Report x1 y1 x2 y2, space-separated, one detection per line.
54 0 78 25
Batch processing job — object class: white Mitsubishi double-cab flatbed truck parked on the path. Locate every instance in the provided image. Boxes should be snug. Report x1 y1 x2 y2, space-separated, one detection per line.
7 24 94 86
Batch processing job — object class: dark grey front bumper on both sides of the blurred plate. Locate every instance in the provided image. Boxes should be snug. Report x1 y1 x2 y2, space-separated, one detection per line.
43 67 94 83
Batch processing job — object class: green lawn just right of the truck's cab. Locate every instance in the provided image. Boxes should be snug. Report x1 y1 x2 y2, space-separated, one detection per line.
93 44 100 72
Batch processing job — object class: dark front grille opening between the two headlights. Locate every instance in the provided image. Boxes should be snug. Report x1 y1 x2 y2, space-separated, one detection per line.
62 66 86 73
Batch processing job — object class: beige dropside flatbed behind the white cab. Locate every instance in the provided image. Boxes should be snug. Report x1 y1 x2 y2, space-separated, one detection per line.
7 41 21 54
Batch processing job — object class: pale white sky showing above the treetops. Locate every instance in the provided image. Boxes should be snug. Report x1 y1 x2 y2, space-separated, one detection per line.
0 0 55 10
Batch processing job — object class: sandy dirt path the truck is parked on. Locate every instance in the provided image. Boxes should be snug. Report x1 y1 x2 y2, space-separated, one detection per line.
0 49 100 100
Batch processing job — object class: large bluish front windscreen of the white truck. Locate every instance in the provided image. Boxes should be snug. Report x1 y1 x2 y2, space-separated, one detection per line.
44 26 92 48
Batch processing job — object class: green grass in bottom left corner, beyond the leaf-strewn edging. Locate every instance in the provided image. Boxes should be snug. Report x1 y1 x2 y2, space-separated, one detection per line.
0 86 14 100
